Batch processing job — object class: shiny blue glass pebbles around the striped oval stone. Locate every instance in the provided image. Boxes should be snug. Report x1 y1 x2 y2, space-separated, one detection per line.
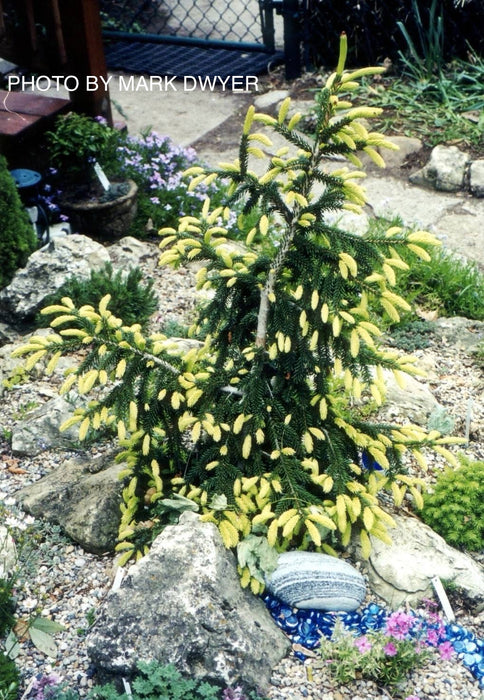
262 594 484 689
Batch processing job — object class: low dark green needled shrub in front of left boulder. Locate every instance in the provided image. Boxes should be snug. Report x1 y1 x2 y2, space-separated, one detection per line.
37 263 158 328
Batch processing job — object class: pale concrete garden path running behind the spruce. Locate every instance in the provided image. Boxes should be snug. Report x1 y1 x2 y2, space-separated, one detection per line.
36 74 484 268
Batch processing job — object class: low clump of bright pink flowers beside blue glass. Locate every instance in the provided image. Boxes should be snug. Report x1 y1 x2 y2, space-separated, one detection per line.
321 601 453 697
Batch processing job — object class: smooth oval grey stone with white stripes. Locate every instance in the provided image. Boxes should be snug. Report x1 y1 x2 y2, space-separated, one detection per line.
266 552 366 611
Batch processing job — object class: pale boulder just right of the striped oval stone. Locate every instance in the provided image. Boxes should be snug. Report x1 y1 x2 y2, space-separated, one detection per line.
356 515 484 609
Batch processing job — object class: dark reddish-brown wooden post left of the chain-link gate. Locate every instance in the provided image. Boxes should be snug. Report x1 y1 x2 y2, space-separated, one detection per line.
59 0 113 126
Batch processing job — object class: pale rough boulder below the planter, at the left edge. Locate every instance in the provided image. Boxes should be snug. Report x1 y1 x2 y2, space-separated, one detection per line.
0 234 109 325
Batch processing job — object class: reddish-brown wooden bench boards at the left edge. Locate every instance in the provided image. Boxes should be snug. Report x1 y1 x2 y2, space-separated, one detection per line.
0 90 71 154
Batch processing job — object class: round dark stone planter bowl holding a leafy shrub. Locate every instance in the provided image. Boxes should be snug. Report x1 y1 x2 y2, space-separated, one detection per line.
62 180 138 242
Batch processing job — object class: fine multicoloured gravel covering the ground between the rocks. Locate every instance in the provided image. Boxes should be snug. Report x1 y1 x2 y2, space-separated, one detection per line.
0 246 484 700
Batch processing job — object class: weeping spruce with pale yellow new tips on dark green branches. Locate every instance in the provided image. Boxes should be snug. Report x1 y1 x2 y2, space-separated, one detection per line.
17 36 462 593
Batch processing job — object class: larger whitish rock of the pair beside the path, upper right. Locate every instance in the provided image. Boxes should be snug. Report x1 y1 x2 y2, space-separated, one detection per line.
410 146 470 192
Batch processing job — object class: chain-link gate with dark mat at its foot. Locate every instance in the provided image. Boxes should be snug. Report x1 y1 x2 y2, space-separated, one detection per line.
101 0 304 79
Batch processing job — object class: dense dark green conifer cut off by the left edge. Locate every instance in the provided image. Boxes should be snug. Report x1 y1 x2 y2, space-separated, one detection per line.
0 155 37 288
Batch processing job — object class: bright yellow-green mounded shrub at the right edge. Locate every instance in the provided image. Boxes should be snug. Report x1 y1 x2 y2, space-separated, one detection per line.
422 457 484 551
